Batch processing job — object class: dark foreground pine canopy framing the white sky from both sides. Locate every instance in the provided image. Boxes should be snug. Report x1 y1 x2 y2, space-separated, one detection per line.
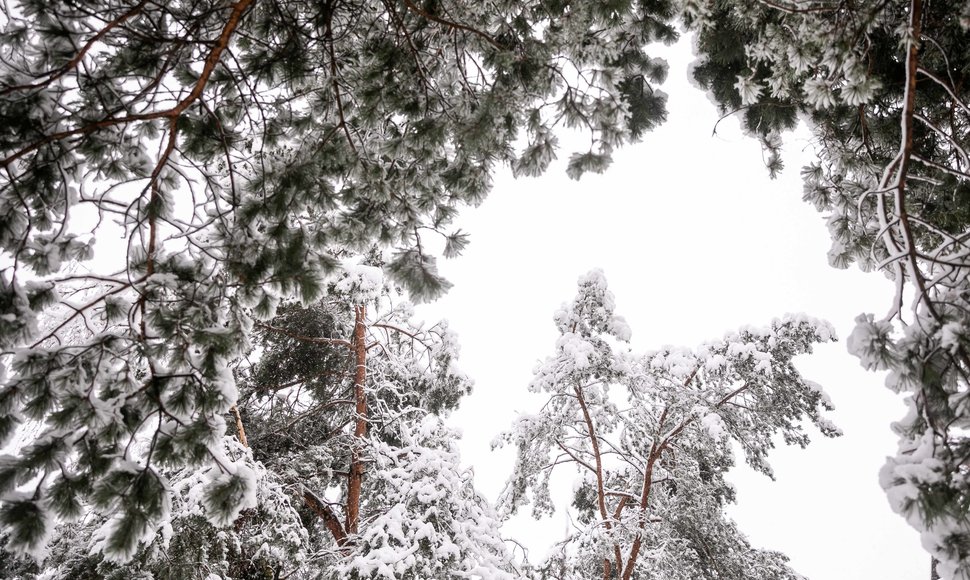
0 0 970 580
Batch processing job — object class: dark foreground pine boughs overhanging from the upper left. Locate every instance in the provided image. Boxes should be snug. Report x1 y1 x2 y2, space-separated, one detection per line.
0 0 676 556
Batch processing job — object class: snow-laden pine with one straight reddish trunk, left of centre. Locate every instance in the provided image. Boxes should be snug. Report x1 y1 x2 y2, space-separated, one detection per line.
234 265 511 578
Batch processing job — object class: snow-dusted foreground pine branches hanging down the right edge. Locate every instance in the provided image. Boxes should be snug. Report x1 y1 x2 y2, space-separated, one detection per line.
687 0 970 580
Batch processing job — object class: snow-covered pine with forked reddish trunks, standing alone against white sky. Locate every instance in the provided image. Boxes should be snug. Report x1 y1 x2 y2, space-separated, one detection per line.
500 271 839 580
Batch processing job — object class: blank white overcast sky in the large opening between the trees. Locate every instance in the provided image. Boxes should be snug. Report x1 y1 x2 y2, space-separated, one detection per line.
420 38 929 580
